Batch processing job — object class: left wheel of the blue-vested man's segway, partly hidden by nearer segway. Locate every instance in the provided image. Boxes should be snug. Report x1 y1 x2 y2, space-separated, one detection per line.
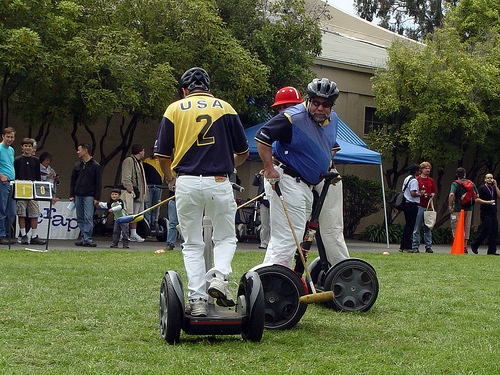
255 264 307 330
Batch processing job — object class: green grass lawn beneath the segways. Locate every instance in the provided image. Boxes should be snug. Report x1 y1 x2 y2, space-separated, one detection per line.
0 250 500 375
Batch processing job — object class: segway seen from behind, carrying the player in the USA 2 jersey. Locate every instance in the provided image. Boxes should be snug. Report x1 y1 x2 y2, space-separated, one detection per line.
159 218 264 344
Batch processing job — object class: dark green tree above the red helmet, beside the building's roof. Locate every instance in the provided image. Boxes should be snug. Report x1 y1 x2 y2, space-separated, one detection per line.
217 0 326 124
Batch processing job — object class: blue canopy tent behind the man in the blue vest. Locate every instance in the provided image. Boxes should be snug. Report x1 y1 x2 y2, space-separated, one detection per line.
245 119 389 248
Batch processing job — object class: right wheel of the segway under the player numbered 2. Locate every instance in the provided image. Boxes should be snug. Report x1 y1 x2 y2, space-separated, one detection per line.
238 272 266 342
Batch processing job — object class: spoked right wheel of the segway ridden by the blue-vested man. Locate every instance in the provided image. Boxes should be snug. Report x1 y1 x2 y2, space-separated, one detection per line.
323 258 378 311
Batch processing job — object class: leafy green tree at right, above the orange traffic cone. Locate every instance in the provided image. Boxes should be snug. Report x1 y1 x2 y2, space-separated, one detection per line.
371 1 500 225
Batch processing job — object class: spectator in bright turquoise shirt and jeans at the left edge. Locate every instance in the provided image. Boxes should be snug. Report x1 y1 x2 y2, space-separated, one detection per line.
0 127 16 245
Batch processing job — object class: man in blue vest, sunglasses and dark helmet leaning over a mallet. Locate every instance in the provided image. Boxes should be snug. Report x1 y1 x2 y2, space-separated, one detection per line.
255 78 339 268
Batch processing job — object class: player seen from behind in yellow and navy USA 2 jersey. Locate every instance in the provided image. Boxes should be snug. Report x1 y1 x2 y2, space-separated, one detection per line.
155 68 248 316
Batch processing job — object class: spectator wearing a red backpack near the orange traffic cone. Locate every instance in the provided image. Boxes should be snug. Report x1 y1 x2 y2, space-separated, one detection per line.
448 167 478 254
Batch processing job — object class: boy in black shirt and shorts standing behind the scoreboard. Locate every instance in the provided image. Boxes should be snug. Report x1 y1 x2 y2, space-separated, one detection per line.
14 138 45 245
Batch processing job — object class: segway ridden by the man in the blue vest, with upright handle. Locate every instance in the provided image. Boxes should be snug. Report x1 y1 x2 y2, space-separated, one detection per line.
252 172 378 330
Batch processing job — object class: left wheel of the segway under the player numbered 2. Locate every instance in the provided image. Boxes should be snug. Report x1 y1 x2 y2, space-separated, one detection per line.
160 273 184 344
